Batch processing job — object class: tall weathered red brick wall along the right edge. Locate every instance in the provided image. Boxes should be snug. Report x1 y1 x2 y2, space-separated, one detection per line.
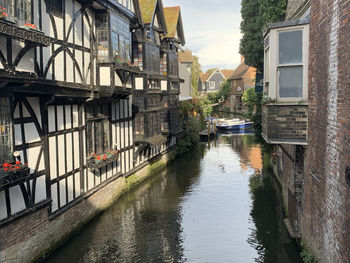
302 0 350 263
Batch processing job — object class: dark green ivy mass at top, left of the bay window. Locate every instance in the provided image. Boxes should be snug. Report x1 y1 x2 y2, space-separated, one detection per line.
240 0 287 72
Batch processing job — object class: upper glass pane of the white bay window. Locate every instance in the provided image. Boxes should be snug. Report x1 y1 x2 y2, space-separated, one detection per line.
279 30 303 65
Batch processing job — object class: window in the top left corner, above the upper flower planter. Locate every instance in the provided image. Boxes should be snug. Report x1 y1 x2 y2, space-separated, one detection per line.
0 0 32 25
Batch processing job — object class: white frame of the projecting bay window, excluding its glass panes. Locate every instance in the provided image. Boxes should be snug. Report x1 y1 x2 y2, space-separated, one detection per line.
264 24 309 103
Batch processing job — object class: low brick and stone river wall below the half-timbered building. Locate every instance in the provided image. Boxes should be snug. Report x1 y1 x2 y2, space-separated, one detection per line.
0 150 174 263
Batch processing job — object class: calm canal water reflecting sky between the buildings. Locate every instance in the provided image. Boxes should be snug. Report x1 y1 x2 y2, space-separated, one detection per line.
45 135 302 263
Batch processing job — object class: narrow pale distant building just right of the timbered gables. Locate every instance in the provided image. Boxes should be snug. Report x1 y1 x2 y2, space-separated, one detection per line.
179 49 193 101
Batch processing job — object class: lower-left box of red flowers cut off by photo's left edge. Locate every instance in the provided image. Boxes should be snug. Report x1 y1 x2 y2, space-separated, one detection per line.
0 163 30 187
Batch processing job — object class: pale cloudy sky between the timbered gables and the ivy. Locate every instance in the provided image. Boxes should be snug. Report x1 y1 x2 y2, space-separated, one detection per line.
163 0 241 71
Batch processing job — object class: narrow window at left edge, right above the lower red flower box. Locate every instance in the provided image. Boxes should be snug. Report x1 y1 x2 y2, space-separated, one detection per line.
0 97 13 164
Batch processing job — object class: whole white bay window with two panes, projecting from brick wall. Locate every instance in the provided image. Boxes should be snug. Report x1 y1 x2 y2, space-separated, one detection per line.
264 24 309 102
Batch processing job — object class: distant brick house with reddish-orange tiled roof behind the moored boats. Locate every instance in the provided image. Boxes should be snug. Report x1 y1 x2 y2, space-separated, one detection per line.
225 57 256 112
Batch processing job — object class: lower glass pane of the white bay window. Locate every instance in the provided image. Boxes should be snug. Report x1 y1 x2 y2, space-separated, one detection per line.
279 67 303 98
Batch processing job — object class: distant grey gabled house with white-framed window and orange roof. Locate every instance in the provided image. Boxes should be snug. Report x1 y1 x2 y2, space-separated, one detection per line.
198 68 234 95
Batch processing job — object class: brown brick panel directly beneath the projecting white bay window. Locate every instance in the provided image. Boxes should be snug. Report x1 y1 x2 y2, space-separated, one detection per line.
262 104 308 143
